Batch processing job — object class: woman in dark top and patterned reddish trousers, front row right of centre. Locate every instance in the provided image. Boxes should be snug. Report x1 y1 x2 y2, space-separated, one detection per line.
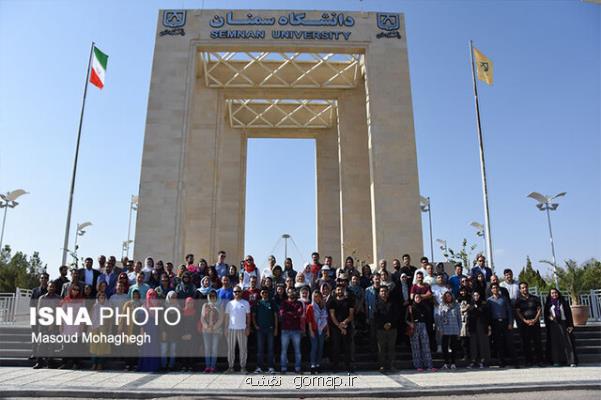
407 294 436 372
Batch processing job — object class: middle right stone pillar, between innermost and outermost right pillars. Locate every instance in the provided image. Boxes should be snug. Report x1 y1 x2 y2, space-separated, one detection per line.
338 87 374 263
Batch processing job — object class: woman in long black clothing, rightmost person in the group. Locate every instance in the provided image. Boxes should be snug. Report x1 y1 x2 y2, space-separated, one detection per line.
545 288 577 367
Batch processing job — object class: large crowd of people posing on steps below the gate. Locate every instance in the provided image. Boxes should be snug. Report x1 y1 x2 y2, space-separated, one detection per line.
32 251 577 374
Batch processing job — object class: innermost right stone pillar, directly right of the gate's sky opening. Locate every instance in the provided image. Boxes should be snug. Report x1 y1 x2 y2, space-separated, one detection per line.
315 128 341 262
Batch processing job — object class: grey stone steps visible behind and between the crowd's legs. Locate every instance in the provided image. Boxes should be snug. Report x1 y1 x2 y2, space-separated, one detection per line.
0 324 601 371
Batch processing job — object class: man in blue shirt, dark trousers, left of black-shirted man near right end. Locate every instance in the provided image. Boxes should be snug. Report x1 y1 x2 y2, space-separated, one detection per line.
488 283 517 368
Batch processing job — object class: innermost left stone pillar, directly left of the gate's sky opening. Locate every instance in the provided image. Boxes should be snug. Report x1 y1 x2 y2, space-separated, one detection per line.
212 122 247 266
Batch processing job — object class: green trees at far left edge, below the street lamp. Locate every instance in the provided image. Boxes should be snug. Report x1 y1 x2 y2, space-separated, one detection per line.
0 245 46 293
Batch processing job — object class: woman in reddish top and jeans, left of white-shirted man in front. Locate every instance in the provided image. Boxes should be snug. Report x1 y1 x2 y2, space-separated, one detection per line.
200 289 224 373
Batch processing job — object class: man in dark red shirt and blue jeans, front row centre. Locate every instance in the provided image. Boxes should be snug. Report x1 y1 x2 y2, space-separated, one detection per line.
279 288 305 374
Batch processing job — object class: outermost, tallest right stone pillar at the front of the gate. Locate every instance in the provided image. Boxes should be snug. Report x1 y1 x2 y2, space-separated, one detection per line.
365 38 423 260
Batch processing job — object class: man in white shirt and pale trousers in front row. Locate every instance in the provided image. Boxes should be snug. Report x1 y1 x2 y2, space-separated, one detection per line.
225 286 250 374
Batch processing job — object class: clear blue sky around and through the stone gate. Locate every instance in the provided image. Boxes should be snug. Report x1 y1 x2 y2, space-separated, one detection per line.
0 0 601 273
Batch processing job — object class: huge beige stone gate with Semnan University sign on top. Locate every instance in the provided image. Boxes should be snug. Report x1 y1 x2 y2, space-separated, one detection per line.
134 10 423 265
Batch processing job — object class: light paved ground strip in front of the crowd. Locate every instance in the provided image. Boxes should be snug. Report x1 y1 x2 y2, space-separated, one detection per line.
0 366 601 398
